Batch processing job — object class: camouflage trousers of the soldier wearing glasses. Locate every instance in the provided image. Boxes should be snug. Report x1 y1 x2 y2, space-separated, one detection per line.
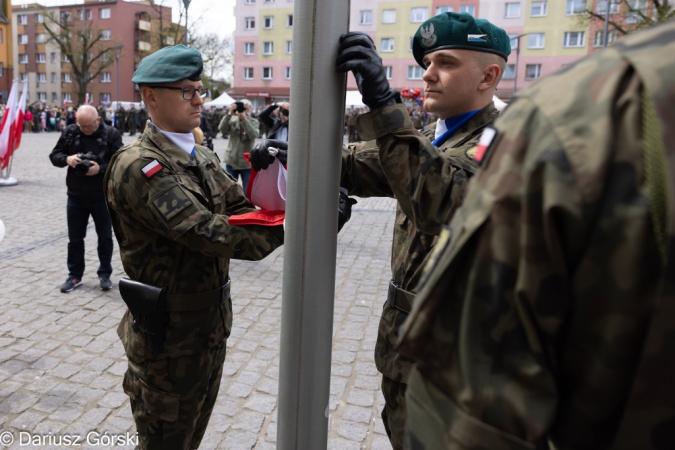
124 341 226 450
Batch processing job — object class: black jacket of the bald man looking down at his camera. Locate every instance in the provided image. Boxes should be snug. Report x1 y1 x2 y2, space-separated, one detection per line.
49 122 122 198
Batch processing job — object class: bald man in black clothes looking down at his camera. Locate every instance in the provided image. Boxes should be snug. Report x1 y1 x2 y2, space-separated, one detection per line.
49 105 122 292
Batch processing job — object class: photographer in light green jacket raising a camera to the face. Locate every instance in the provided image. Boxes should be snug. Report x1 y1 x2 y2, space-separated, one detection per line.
218 100 260 192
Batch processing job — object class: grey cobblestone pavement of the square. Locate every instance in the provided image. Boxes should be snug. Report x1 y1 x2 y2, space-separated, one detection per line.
0 133 395 450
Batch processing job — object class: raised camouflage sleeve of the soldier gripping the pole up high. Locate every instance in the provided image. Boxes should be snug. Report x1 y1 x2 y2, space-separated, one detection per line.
357 105 475 235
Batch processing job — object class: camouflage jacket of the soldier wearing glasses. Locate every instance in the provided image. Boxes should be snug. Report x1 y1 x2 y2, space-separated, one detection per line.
104 123 283 357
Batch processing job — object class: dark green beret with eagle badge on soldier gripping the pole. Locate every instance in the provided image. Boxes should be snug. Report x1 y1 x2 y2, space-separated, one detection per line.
413 12 511 67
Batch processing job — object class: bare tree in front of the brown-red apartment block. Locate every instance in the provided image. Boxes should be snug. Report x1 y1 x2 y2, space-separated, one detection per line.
41 7 118 104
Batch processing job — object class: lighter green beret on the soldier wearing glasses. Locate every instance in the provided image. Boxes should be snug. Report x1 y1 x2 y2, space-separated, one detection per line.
131 44 204 84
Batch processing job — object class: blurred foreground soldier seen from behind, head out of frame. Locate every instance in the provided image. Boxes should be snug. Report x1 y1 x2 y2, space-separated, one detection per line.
400 20 675 450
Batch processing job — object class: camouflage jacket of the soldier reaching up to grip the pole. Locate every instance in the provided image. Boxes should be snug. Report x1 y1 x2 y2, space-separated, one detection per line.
340 103 498 382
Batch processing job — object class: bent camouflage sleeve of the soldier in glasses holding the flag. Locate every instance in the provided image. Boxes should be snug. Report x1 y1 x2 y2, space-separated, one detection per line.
109 159 283 261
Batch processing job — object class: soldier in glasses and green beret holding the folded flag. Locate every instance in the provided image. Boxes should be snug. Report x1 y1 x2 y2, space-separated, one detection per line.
104 45 283 450
